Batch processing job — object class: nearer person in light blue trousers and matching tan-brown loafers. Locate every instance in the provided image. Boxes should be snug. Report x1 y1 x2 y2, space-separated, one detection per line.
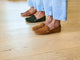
32 0 67 34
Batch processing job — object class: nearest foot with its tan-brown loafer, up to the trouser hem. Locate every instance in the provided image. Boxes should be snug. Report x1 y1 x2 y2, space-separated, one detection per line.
34 19 61 35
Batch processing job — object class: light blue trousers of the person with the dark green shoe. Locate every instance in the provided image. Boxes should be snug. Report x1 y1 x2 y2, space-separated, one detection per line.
28 0 44 11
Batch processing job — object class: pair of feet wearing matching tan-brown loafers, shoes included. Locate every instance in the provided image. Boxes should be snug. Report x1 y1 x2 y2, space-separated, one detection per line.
32 16 61 34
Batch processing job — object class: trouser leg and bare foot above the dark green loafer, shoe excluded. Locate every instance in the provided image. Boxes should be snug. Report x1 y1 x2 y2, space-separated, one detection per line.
34 0 45 19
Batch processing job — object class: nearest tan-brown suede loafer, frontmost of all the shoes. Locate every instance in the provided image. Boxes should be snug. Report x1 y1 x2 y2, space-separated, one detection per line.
34 25 61 35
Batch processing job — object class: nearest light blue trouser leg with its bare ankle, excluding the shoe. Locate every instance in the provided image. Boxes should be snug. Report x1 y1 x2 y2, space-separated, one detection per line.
48 0 67 30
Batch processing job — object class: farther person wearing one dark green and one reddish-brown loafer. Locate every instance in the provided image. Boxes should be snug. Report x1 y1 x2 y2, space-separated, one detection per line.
21 0 46 23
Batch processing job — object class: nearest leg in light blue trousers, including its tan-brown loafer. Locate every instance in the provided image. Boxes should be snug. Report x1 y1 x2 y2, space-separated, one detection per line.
35 0 67 34
